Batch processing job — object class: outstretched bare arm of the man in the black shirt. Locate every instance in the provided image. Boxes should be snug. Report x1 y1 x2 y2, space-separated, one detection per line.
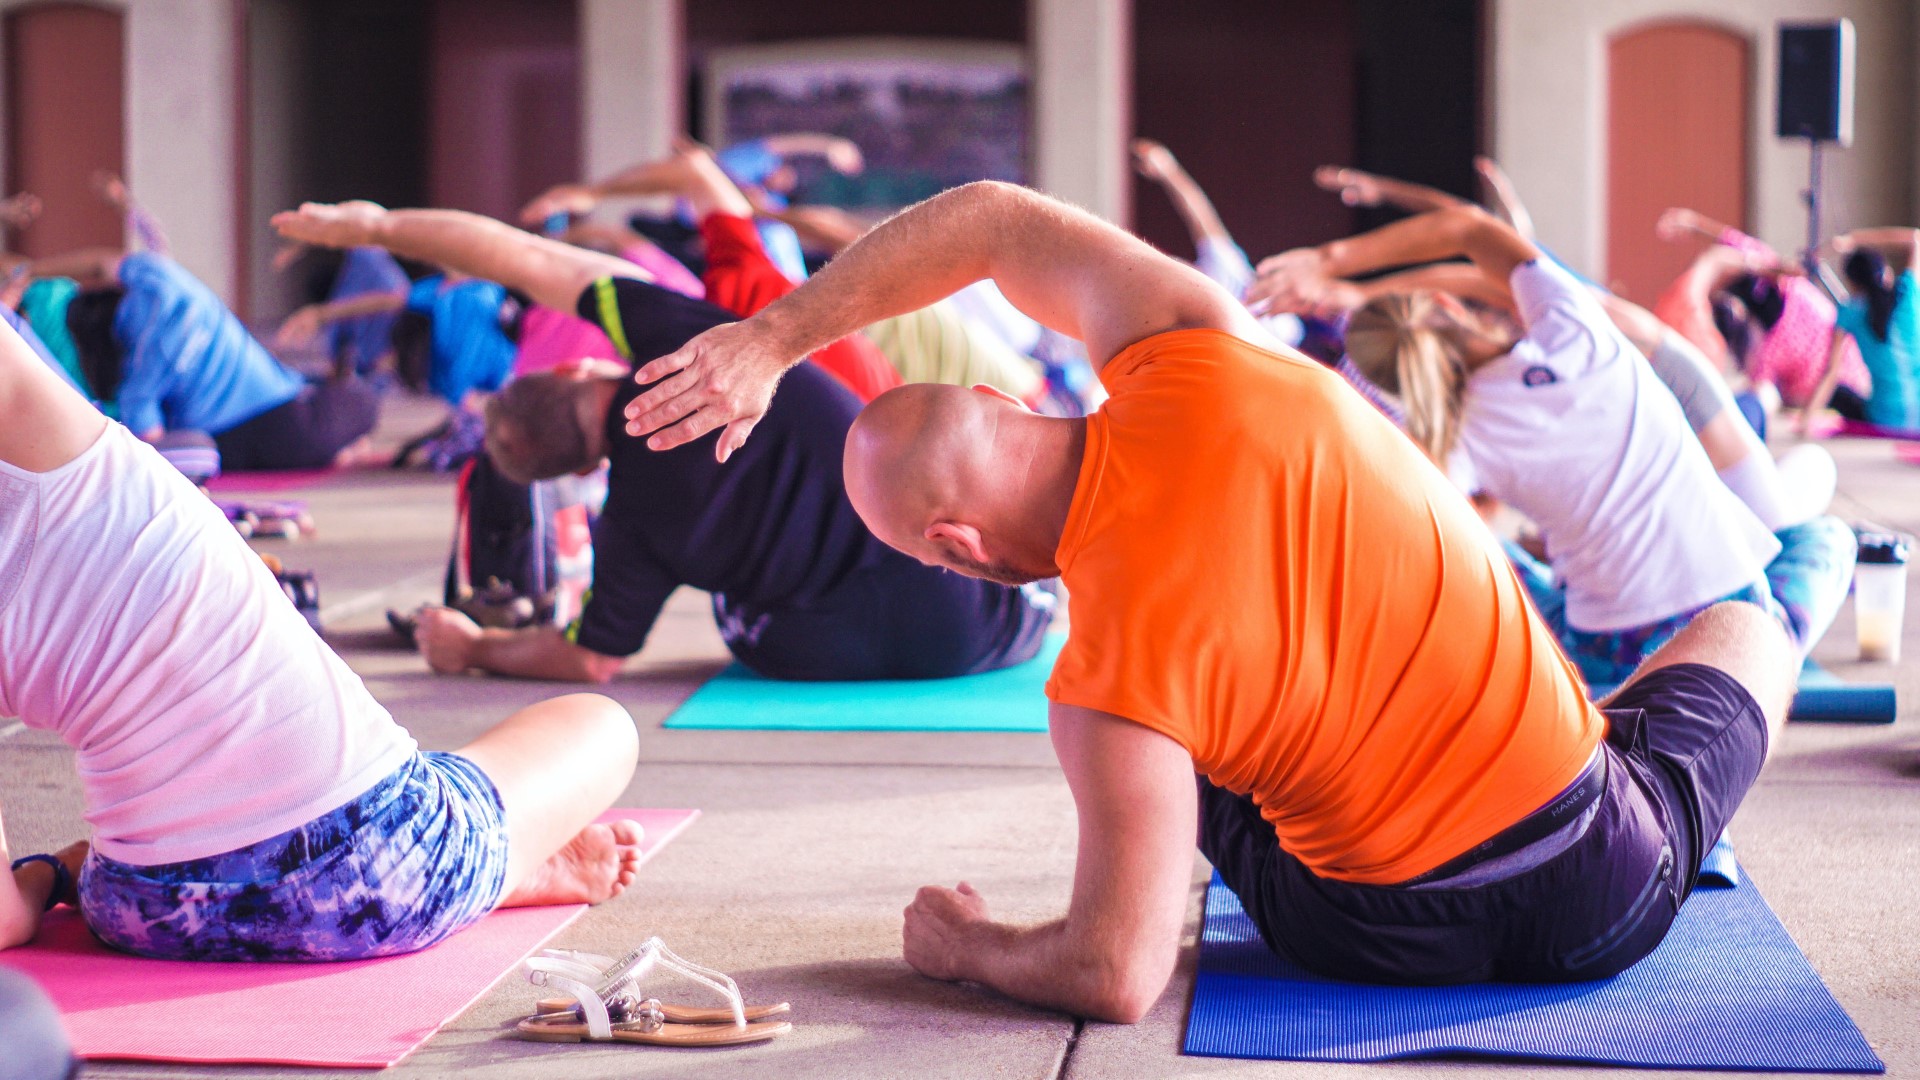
273 202 651 311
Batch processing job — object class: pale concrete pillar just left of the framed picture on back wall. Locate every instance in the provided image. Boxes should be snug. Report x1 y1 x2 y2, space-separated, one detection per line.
580 0 687 177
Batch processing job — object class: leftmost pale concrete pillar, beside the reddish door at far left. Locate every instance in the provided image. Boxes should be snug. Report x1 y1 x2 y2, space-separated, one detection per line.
127 0 240 304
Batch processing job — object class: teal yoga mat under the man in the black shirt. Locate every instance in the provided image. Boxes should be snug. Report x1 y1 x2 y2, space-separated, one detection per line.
666 634 1068 732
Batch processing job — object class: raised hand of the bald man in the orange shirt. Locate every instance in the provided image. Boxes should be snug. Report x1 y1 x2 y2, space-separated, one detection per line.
626 319 795 461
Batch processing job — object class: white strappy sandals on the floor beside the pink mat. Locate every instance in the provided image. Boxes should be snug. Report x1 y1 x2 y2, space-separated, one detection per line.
516 938 793 1045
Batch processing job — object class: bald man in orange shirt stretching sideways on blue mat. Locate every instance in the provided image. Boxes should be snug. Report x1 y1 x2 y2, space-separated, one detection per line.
602 183 1795 1022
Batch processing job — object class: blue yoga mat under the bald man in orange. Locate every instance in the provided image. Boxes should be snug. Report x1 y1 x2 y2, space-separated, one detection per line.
1187 876 1885 1072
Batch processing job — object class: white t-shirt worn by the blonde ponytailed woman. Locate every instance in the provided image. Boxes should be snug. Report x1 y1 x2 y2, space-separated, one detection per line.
1461 259 1780 632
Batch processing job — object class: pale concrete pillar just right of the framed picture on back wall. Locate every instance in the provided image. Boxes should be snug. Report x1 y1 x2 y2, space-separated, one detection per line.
1029 0 1133 225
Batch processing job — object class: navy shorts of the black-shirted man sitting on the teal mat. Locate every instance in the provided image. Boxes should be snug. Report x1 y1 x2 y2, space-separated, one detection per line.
714 550 1058 680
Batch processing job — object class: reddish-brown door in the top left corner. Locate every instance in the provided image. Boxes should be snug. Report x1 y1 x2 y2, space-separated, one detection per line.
4 4 125 256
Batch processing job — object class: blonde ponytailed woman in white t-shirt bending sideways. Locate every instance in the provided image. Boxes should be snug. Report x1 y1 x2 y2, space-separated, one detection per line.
1263 208 1853 686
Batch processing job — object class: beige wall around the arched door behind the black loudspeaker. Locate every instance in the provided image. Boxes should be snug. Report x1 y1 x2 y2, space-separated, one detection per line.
1488 0 1920 275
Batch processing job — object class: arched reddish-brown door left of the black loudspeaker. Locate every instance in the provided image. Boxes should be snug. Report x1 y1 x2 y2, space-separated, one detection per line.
1605 21 1753 304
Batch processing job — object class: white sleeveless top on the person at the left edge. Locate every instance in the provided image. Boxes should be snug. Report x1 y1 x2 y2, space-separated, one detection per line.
0 423 415 865
